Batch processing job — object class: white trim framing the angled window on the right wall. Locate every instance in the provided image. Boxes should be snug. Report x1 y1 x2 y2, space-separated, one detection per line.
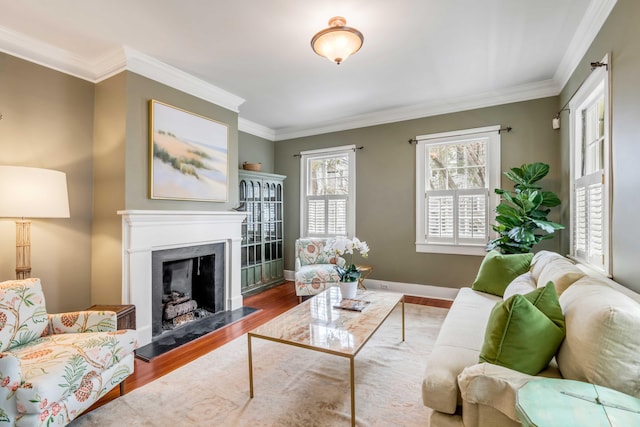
569 54 613 277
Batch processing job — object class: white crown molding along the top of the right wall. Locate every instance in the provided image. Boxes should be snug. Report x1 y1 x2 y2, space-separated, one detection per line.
553 0 618 88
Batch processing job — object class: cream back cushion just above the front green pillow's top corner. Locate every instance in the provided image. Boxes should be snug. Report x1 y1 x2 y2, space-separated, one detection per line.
531 251 586 296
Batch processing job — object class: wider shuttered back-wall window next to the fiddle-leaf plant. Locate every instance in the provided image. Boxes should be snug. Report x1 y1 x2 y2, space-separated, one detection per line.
416 126 500 255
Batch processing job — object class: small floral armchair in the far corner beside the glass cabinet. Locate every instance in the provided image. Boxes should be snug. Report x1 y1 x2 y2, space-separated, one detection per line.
295 238 345 300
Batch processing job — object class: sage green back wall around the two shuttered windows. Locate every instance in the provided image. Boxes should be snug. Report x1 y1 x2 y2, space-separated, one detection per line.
275 97 562 288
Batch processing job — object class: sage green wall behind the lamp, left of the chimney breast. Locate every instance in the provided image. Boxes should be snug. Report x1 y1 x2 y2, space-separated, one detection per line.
0 53 94 313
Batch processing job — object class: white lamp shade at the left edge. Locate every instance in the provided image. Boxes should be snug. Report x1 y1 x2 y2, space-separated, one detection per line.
0 166 69 218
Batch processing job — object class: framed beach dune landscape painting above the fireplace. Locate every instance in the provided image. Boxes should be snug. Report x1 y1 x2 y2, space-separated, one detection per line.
149 99 229 202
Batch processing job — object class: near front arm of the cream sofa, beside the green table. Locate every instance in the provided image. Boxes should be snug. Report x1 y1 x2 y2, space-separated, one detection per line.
458 363 539 422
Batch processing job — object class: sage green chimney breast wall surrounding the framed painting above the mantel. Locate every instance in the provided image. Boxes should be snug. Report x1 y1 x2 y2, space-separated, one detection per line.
92 71 238 304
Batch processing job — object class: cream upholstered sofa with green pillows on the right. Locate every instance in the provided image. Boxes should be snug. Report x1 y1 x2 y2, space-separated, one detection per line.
422 251 640 427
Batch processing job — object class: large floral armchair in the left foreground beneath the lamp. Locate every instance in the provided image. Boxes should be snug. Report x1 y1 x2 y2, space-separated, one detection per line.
0 278 137 427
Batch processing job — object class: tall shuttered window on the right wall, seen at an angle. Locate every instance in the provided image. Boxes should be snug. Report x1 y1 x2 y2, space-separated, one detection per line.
569 57 611 275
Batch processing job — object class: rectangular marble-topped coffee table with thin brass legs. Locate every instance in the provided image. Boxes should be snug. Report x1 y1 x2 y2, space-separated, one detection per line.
247 286 404 426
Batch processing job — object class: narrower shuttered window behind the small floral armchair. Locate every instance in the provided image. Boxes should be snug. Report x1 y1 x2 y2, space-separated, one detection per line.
300 146 356 237
